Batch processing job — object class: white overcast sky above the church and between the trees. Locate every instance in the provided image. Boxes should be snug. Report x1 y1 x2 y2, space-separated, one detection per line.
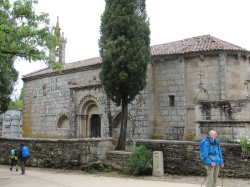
13 0 250 97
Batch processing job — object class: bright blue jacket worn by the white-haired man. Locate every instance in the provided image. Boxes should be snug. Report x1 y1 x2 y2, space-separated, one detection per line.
203 137 224 166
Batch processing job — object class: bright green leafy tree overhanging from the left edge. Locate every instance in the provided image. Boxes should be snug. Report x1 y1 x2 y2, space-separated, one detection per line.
0 0 61 113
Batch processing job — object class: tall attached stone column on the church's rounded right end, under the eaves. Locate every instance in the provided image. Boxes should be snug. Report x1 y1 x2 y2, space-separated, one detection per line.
219 53 227 100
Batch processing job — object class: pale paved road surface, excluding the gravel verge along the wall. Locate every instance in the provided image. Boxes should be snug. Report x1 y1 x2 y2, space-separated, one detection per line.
0 166 200 187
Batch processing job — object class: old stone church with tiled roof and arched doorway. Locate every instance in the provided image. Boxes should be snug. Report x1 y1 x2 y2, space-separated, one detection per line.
23 35 250 143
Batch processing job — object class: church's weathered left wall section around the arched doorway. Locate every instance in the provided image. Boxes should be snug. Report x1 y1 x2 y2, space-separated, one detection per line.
23 64 151 140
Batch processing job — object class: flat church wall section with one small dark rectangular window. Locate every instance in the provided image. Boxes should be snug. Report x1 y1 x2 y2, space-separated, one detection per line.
152 59 186 140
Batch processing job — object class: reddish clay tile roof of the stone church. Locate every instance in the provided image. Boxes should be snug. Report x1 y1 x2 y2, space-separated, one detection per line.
23 35 249 79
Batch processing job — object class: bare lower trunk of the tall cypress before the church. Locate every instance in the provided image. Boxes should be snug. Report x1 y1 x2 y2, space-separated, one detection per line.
115 101 128 150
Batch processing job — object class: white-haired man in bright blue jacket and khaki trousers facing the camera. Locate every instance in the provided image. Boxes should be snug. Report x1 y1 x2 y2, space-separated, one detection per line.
203 130 224 187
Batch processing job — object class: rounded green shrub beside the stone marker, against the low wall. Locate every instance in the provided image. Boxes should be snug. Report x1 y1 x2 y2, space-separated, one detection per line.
128 145 153 175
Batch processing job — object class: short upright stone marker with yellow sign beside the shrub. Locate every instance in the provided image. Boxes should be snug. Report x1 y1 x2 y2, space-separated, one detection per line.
153 151 164 177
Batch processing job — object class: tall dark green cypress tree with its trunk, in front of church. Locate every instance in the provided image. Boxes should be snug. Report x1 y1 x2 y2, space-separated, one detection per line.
99 0 151 150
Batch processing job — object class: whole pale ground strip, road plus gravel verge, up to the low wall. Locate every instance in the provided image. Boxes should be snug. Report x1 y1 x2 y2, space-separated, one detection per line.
0 165 250 187
